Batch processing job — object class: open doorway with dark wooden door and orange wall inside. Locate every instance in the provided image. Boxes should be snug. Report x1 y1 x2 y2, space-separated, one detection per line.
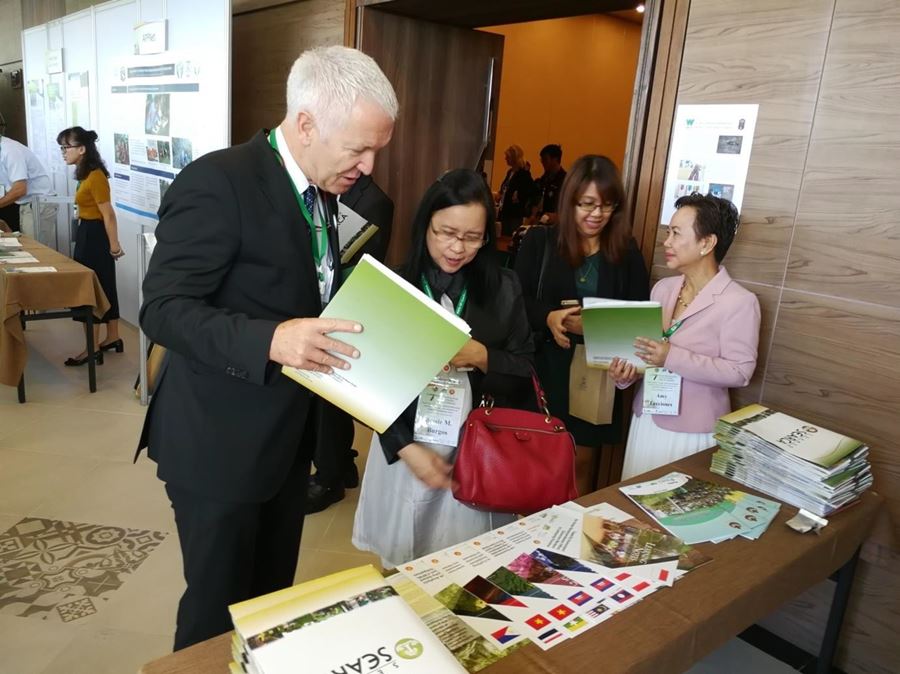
345 0 689 264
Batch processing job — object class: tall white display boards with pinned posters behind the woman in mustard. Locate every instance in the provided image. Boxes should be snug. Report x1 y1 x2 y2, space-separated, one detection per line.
22 0 231 325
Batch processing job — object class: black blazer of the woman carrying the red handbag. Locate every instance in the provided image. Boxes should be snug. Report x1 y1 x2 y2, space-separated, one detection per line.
379 269 536 463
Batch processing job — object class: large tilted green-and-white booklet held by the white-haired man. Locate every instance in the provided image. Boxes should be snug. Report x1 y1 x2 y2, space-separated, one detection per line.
282 255 470 433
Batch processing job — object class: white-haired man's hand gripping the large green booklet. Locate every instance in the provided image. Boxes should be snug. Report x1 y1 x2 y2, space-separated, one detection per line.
269 318 362 374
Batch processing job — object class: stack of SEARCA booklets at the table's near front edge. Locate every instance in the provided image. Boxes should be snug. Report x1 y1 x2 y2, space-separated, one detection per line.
229 566 465 674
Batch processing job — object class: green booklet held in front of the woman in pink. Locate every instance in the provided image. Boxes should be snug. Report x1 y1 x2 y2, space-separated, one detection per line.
581 297 662 372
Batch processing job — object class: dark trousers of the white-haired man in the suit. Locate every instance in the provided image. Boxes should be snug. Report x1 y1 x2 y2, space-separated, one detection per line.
166 444 309 651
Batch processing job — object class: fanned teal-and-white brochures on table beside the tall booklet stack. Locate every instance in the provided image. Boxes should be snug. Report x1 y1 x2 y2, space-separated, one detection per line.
619 472 781 544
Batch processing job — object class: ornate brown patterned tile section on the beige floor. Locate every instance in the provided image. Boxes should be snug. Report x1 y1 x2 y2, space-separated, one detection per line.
0 517 167 623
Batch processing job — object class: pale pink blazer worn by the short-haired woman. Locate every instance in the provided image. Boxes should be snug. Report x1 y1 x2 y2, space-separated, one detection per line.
634 267 759 433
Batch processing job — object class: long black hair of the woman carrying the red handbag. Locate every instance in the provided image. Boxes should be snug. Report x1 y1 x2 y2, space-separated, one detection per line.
403 169 500 303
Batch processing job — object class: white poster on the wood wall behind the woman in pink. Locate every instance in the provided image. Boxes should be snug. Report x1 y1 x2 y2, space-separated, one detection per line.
660 104 759 226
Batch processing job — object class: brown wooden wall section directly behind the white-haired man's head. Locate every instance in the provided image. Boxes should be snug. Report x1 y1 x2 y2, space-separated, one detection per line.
231 0 345 143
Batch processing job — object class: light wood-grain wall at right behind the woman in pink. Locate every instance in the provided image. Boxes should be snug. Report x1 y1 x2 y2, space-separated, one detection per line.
668 0 900 674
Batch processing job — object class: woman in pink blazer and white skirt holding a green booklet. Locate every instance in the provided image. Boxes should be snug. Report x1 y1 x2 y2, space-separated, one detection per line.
610 194 759 479
